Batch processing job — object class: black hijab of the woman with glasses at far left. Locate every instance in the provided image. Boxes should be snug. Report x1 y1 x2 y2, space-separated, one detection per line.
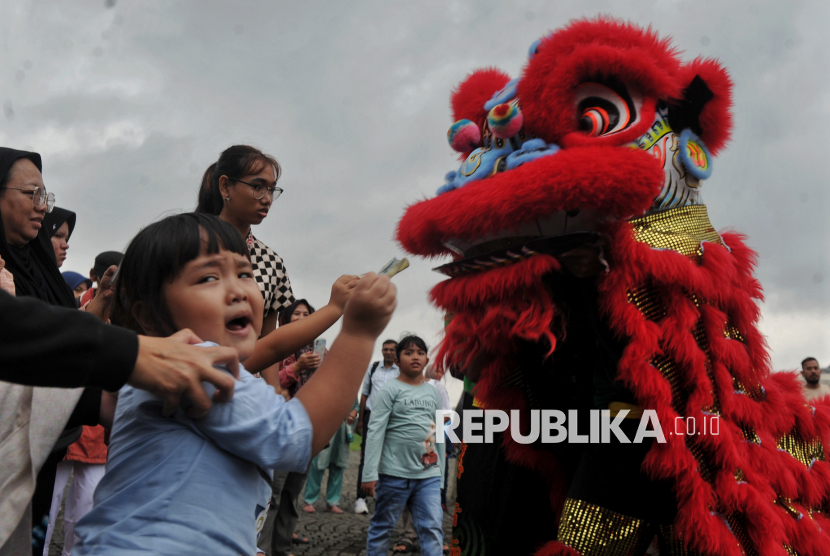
0 147 75 308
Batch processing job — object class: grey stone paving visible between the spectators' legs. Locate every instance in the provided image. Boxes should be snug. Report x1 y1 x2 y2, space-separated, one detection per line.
49 452 452 556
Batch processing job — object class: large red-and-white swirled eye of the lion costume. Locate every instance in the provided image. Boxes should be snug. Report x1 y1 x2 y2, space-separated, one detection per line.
576 83 636 137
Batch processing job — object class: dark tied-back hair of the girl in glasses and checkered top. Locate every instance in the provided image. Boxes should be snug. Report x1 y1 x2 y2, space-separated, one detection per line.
196 145 282 216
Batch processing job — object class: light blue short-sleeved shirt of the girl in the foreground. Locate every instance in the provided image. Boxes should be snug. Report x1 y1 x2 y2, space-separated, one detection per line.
72 342 312 556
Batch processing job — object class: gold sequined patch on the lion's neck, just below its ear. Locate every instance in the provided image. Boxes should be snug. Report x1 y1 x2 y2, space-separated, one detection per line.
630 205 723 259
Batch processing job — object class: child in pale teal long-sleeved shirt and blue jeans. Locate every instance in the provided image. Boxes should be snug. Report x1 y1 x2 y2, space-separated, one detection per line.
362 336 444 556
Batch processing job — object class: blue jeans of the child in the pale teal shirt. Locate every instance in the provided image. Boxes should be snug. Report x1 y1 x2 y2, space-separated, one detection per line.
366 475 444 556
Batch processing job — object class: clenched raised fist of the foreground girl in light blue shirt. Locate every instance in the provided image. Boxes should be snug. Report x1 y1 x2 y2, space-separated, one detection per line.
343 272 397 341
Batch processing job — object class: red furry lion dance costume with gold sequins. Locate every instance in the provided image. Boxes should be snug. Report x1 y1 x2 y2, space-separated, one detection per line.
398 18 830 556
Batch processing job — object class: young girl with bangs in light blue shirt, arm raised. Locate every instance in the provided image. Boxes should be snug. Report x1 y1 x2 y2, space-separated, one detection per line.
73 214 395 556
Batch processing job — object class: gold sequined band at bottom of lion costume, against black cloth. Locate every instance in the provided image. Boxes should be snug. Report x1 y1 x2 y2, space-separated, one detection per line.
558 498 654 556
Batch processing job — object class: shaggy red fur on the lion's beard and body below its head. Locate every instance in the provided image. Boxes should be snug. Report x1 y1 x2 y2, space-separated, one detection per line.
432 222 830 556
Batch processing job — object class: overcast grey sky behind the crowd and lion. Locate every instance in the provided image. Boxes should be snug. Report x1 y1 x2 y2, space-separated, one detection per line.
0 0 830 382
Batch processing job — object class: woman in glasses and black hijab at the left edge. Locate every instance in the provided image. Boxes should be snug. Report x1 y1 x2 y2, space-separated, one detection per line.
0 147 75 308
